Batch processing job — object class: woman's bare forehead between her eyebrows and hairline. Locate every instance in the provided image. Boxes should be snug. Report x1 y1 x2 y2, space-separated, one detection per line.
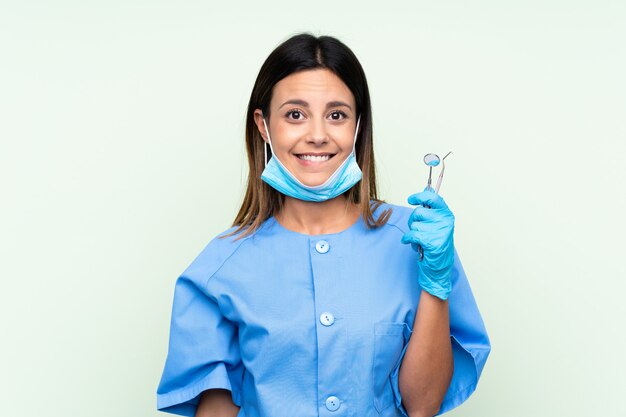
272 68 354 108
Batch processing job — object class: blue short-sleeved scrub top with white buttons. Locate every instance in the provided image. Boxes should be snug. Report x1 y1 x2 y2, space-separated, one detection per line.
157 203 490 417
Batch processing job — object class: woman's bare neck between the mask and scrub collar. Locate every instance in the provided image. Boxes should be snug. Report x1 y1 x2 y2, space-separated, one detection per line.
276 195 361 235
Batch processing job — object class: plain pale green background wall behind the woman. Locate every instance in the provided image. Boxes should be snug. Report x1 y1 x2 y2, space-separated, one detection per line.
0 0 626 417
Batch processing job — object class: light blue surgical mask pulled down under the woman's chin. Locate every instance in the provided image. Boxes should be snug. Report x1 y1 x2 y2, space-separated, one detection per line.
261 116 361 201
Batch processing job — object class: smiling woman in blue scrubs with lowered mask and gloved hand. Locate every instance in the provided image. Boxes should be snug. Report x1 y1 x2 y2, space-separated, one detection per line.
157 34 490 417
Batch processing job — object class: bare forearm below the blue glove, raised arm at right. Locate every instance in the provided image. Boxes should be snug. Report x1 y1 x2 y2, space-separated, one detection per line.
398 291 454 417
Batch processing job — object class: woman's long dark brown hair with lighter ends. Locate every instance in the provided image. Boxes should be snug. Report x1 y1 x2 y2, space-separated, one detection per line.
223 33 391 238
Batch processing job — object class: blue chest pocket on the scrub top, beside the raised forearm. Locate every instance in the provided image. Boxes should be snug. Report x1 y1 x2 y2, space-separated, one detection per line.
372 322 407 413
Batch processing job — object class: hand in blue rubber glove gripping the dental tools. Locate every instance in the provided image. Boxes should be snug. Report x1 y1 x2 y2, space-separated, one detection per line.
402 187 454 300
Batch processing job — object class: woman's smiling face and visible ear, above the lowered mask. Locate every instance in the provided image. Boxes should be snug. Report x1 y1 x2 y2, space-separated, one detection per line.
254 69 357 185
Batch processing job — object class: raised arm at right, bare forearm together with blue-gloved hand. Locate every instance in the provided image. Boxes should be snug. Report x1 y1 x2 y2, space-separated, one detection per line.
398 190 455 417
